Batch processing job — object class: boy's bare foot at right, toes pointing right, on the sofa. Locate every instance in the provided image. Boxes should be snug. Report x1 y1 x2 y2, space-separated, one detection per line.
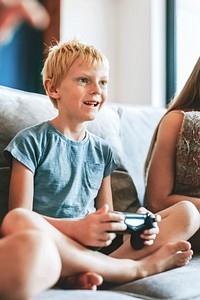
142 241 193 277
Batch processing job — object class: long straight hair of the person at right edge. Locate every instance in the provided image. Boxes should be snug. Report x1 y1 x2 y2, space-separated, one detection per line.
144 58 200 176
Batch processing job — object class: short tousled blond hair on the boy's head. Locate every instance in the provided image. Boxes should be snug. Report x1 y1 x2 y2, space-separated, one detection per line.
42 38 109 107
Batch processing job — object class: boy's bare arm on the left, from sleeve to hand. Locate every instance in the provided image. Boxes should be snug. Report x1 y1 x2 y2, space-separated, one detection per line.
9 159 126 247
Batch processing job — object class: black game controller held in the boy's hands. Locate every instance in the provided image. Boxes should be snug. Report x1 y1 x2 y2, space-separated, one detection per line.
115 213 157 250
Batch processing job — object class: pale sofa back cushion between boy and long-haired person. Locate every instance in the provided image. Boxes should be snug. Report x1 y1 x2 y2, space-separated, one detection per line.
118 104 165 205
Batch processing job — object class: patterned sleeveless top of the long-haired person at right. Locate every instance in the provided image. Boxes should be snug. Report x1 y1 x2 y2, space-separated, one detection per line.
174 111 200 198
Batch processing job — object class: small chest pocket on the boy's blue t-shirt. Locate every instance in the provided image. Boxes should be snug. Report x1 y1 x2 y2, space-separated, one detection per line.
85 163 104 190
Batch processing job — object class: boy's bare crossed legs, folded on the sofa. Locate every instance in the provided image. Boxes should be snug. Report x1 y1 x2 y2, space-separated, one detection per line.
2 202 199 285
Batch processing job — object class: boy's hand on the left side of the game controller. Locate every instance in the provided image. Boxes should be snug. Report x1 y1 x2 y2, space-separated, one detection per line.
74 205 127 247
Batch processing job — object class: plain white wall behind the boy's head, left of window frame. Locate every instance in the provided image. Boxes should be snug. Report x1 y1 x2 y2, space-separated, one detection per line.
61 0 165 106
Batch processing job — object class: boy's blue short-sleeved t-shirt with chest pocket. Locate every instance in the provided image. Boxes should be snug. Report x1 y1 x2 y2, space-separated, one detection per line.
4 121 118 218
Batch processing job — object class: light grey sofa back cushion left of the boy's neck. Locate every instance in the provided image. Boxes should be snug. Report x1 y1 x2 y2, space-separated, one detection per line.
0 86 57 167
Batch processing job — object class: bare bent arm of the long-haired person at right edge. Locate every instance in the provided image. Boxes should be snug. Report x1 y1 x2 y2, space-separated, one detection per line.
145 111 200 212
